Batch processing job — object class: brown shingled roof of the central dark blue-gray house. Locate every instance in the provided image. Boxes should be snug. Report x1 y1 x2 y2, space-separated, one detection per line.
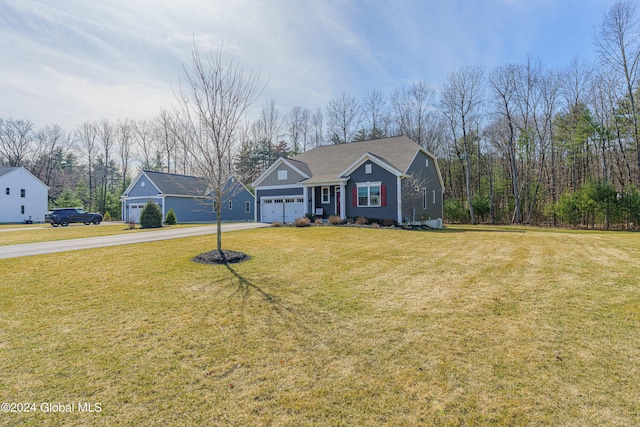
289 136 435 184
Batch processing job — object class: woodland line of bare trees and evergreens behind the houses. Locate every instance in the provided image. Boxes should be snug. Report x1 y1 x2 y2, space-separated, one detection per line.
0 1 640 228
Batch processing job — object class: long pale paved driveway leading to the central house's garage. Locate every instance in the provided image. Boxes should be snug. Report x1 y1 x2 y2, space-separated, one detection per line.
0 222 269 259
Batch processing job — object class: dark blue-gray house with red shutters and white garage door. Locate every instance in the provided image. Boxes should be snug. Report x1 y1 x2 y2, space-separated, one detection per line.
252 136 444 227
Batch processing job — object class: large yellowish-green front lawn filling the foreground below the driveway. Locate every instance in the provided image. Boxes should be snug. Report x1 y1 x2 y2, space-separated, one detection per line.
0 227 640 426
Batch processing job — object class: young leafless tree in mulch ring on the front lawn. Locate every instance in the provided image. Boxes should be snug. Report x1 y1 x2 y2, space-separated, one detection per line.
176 45 263 253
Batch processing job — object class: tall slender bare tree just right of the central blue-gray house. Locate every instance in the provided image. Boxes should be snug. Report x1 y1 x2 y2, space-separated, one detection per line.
441 65 484 224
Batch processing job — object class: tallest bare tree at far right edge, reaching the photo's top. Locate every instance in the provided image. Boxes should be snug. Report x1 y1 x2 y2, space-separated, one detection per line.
594 0 640 183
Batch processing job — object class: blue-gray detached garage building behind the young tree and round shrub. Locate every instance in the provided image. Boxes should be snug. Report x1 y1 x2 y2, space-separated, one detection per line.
120 170 254 223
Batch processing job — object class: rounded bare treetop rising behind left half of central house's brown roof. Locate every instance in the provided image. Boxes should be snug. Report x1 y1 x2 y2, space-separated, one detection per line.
327 92 360 144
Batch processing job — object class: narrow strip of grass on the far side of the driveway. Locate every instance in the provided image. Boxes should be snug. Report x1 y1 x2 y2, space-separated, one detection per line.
0 223 205 246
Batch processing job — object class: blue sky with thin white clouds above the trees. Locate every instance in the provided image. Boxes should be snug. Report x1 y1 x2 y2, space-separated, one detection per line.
0 0 614 130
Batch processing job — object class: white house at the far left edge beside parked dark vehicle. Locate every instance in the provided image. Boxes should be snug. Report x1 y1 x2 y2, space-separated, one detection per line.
0 167 49 222
